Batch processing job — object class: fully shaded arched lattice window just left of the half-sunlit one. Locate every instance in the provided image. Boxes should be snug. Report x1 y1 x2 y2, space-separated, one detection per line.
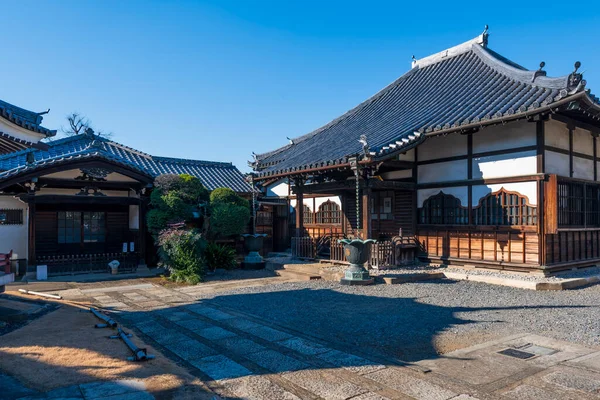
419 192 469 225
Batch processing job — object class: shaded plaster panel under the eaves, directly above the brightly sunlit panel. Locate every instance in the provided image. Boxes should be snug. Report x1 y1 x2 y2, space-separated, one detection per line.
474 121 536 153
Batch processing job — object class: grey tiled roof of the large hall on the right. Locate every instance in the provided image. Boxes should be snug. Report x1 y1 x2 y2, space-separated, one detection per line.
251 33 600 177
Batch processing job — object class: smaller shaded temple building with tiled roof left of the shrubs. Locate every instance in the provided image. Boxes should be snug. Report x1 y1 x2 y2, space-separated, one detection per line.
0 128 251 275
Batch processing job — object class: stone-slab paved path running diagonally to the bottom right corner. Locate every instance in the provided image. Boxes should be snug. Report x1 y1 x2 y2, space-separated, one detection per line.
61 284 600 400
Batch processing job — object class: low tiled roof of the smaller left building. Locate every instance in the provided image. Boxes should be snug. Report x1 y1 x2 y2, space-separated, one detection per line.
0 134 251 193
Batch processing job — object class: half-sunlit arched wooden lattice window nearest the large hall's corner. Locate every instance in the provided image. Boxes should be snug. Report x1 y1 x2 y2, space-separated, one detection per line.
473 189 537 226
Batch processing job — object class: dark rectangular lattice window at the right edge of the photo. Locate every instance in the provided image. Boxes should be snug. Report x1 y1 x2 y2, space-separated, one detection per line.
558 181 600 228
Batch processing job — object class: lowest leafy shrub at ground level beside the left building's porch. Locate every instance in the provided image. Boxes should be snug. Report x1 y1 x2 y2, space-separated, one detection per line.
158 229 206 285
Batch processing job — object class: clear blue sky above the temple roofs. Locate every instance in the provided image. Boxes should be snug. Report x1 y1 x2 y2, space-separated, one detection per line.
0 0 600 171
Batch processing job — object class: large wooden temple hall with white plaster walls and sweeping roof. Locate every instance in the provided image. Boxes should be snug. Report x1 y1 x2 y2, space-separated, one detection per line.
251 28 600 274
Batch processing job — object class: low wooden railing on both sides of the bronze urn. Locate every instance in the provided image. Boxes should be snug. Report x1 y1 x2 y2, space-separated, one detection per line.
292 236 418 268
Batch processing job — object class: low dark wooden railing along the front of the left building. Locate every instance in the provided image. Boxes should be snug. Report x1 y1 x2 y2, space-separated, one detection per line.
36 253 139 276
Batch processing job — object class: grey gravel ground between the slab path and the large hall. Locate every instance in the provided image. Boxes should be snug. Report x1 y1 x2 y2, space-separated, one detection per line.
197 280 600 361
